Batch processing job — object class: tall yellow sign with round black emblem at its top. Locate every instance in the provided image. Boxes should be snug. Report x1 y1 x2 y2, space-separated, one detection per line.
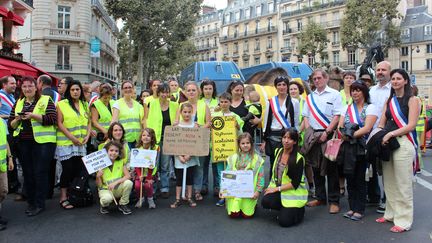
212 116 237 162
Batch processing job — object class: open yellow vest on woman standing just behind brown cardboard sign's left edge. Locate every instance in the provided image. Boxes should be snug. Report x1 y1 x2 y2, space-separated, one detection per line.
147 98 179 144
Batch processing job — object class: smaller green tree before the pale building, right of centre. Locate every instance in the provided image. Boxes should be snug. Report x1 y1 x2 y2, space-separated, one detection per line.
299 21 329 65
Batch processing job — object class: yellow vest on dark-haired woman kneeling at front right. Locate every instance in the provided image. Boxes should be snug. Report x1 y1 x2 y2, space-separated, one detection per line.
268 148 308 208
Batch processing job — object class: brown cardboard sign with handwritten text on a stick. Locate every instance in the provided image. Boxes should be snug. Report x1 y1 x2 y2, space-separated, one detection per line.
163 126 210 156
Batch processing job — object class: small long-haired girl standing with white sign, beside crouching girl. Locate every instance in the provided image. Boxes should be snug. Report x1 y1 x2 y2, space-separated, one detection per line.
135 128 159 209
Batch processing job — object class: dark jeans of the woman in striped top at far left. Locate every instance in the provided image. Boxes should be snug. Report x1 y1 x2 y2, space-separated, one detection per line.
18 140 56 208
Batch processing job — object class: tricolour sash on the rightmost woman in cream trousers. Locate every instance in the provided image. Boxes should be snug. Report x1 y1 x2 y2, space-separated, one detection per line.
389 96 420 173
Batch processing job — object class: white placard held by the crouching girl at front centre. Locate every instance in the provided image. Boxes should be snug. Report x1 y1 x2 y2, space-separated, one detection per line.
220 170 254 198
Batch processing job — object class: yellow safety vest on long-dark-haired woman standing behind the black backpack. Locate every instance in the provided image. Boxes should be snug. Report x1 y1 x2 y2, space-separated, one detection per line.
57 100 89 146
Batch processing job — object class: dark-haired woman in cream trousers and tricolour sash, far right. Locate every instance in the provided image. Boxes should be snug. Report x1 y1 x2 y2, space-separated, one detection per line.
376 69 419 233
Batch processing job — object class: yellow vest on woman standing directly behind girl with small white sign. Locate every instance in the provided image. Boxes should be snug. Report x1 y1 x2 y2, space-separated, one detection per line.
117 98 144 143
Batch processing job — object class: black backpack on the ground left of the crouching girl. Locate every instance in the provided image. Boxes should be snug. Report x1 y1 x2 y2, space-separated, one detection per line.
67 176 93 208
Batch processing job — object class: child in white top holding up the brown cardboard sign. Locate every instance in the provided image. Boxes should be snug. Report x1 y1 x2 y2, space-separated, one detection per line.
171 103 199 208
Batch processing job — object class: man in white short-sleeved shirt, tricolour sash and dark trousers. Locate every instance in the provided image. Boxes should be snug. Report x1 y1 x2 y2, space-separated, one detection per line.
303 69 343 213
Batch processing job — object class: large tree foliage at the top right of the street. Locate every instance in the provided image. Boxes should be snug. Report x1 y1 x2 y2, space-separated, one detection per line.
341 0 402 49
